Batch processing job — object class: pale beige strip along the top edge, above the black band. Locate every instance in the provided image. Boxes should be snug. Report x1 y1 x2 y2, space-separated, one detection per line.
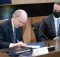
11 0 60 4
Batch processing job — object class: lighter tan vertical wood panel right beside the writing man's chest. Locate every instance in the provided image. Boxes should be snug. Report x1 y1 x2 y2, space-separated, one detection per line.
23 18 32 44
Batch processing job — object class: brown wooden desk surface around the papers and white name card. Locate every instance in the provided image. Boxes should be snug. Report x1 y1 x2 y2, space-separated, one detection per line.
0 40 60 57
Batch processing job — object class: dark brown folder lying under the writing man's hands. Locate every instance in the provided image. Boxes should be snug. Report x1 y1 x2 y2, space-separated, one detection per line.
0 46 32 54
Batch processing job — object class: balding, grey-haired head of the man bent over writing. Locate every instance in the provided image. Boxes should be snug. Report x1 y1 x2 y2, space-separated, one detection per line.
13 9 27 27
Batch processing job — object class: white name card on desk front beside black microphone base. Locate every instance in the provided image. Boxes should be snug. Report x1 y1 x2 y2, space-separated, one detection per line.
32 47 48 56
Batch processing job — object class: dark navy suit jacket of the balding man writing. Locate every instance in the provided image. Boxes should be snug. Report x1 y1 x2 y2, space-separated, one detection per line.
0 20 23 49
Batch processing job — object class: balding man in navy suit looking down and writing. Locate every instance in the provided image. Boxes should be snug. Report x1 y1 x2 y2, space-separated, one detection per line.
0 9 27 49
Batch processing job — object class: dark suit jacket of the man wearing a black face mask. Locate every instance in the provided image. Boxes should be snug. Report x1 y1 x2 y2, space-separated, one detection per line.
38 14 56 41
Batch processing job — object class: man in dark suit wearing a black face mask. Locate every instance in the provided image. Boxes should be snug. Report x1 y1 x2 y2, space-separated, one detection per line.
38 2 60 41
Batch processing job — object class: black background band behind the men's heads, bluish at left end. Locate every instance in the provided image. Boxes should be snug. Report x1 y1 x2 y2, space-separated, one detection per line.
0 3 54 19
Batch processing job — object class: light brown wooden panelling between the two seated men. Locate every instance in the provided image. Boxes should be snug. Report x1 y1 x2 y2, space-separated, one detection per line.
23 16 46 43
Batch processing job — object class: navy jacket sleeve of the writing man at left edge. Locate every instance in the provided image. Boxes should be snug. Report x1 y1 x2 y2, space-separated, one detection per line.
0 25 10 49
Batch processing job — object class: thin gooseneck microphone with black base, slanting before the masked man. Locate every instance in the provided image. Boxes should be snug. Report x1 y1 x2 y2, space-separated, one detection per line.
32 23 55 51
